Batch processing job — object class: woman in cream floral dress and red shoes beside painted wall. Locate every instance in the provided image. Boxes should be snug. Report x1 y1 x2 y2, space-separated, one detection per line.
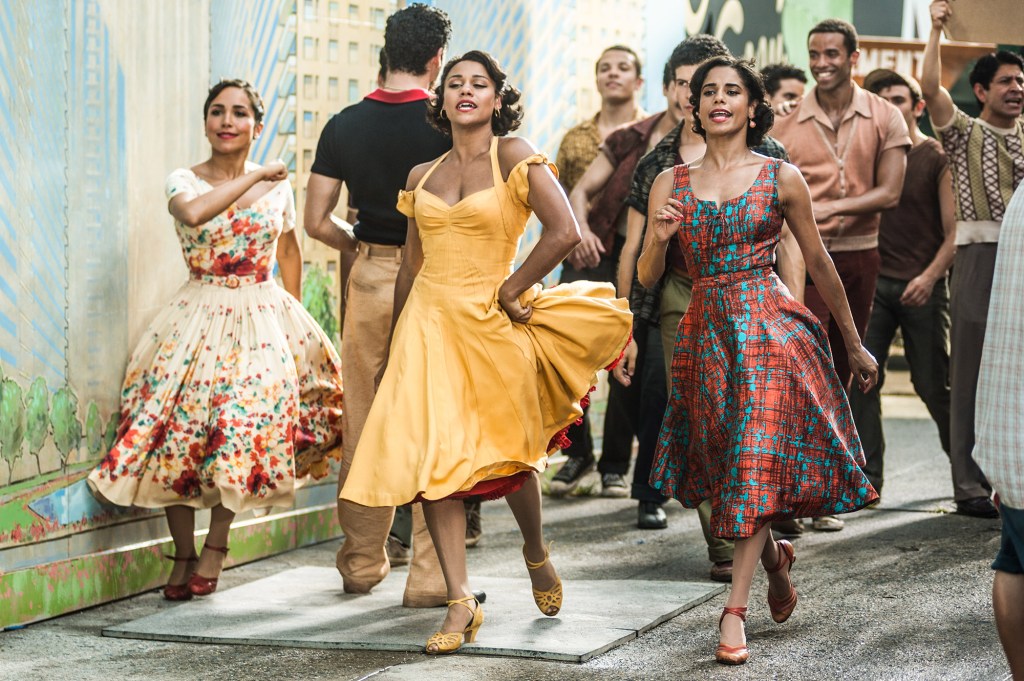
89 80 342 600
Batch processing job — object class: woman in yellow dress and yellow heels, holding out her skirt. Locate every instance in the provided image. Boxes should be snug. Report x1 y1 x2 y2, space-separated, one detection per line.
341 51 632 654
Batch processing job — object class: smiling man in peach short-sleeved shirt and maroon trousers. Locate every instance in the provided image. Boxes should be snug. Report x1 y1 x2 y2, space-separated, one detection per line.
772 18 910 530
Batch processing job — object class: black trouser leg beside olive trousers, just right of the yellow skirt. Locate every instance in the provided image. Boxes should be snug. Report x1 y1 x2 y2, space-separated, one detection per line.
630 322 668 504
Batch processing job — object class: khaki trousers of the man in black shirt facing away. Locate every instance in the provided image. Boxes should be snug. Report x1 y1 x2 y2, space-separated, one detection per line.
337 242 447 607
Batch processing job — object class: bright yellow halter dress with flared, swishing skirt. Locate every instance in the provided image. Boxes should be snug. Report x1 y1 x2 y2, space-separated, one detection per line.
341 137 632 506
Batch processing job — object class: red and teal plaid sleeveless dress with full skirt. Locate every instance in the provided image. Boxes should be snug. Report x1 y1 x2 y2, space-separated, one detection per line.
650 159 878 538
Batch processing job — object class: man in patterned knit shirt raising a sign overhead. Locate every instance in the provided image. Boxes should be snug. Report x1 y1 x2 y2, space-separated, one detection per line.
921 1 1024 518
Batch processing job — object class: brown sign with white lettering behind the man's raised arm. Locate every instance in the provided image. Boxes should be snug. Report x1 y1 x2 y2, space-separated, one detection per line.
853 36 995 89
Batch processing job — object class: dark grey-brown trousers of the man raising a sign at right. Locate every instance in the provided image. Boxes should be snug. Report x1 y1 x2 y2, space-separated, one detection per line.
949 244 996 501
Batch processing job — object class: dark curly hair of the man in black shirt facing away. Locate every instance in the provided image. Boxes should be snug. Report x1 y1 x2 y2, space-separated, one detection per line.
384 2 452 76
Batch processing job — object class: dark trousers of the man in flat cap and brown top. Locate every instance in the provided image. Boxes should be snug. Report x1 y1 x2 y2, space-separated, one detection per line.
850 275 956 493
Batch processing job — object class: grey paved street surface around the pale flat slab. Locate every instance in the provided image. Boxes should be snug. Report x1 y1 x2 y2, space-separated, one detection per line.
0 377 1009 681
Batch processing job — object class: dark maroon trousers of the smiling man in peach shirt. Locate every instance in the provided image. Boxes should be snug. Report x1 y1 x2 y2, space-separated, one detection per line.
804 248 881 391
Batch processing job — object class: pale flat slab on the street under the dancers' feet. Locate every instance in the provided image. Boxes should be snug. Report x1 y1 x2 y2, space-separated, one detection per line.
103 566 724 663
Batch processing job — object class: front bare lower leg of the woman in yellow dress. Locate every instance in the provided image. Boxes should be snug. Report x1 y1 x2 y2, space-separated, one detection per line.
423 499 473 633
